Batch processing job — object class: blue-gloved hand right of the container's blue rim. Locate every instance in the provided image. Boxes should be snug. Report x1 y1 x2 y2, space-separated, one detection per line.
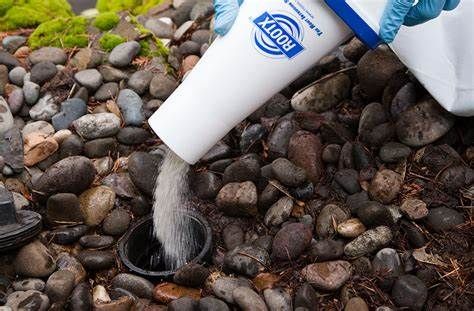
379 0 461 43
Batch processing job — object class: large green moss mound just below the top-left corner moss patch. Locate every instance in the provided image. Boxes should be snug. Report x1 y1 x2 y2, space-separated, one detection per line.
28 16 89 49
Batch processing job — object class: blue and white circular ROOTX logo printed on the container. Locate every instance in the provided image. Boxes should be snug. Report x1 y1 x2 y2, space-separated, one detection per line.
253 12 304 59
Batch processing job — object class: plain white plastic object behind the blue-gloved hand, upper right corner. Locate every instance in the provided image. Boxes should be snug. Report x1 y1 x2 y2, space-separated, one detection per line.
347 0 474 116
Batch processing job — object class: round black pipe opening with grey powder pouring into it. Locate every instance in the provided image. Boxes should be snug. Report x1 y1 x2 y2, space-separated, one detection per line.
118 210 212 280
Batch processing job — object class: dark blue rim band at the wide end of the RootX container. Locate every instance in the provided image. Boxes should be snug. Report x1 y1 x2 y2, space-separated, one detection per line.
324 0 383 49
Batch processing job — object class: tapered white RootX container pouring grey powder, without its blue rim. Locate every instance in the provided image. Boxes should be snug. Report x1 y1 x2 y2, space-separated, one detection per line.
148 0 351 164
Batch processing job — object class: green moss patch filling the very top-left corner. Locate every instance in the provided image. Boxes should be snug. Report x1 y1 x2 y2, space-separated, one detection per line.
0 0 74 30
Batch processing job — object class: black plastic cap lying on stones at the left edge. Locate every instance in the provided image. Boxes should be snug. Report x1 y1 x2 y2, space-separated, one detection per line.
0 186 42 252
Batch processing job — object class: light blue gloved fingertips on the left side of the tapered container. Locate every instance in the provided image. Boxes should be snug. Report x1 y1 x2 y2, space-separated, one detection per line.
214 0 244 36
